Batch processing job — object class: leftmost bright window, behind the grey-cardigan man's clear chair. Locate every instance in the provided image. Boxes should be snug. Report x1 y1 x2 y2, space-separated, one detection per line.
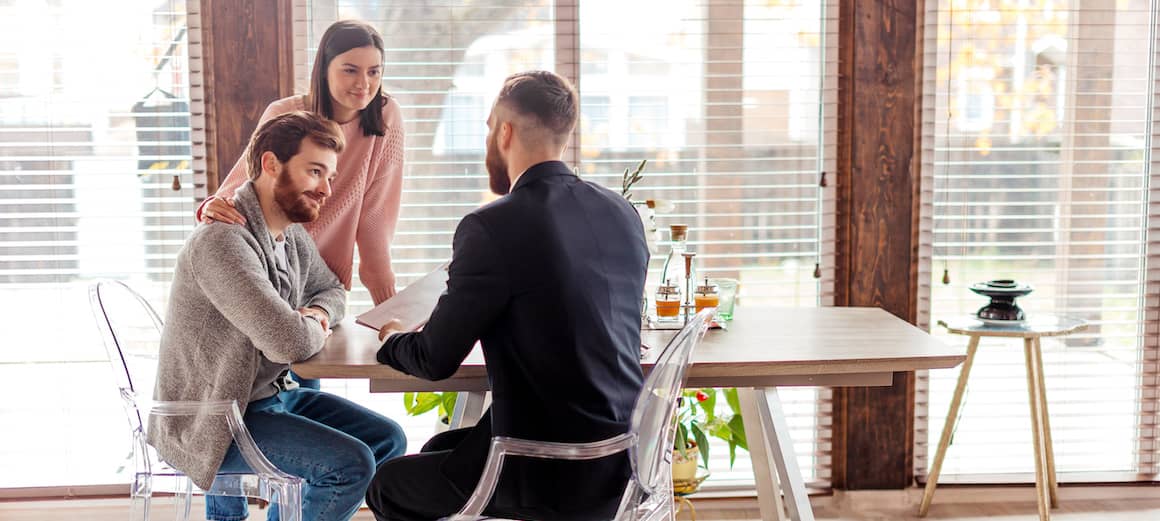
0 0 194 487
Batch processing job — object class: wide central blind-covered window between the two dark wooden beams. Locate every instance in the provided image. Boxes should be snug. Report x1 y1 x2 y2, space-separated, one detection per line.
296 0 838 486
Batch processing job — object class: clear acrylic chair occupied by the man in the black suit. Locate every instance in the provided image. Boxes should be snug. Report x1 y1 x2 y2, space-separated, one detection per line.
444 307 717 521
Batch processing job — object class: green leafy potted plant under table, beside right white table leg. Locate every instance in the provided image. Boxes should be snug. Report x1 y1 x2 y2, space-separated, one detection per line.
673 388 749 466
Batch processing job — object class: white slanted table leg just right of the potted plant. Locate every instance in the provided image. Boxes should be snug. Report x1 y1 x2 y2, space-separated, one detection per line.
739 388 813 521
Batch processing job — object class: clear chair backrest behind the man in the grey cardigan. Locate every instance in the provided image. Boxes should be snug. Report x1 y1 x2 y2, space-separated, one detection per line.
88 281 161 429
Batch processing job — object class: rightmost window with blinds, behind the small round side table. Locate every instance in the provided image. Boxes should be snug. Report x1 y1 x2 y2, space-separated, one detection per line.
915 0 1160 482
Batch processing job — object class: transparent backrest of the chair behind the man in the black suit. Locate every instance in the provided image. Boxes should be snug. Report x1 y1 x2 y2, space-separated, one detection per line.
629 307 717 494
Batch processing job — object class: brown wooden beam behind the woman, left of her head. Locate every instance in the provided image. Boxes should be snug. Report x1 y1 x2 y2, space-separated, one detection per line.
201 0 293 194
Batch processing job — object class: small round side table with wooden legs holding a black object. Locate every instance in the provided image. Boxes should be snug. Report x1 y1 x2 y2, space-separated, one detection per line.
919 316 1087 521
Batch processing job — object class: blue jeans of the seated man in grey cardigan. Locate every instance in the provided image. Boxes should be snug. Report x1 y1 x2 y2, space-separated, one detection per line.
205 388 407 521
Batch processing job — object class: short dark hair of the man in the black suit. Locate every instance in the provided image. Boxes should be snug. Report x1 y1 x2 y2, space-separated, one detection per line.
495 71 580 145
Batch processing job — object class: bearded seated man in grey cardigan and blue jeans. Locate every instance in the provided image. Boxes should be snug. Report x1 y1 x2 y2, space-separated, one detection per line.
150 113 406 521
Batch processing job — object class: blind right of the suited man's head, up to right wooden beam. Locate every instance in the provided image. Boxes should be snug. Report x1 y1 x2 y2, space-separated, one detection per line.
579 0 838 486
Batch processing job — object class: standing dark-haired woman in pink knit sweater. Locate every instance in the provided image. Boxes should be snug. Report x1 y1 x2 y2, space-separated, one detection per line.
197 20 403 304
